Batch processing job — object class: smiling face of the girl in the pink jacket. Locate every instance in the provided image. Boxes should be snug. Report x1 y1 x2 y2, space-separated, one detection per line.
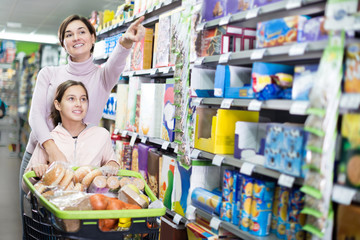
54 85 88 123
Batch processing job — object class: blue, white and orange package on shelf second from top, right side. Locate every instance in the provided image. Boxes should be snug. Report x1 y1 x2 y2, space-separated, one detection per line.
256 16 308 48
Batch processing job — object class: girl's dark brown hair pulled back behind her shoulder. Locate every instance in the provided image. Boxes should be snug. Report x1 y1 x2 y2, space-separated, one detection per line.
50 80 89 127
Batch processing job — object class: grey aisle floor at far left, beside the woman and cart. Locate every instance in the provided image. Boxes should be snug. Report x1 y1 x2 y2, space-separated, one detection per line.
0 146 22 240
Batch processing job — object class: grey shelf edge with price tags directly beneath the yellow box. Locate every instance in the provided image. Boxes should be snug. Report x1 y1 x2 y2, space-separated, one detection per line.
194 151 304 185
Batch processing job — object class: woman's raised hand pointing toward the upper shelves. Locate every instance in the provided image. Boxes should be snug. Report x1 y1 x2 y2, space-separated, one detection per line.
119 16 145 49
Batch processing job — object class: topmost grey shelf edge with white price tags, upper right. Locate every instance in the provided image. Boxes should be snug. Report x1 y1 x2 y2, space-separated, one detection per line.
198 0 326 30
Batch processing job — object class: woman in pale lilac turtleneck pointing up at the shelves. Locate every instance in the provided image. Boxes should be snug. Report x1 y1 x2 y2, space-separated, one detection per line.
19 12 145 234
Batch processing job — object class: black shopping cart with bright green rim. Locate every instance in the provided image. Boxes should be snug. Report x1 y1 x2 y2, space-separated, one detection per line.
23 170 166 240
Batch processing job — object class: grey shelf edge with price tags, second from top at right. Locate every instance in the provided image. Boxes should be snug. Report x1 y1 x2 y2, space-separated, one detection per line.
194 41 327 67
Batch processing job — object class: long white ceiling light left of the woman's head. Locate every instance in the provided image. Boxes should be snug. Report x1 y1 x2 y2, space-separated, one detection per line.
0 31 58 44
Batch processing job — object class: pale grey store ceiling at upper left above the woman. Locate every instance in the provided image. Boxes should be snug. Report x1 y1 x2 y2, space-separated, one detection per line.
0 0 124 43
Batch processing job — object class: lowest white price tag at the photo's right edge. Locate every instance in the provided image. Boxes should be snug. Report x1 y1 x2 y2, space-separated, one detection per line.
332 184 360 205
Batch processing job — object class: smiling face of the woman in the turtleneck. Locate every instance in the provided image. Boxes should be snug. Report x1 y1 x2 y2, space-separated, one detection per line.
63 20 95 62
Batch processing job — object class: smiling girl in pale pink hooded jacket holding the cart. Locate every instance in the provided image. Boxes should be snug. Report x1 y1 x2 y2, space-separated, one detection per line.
25 80 120 183
